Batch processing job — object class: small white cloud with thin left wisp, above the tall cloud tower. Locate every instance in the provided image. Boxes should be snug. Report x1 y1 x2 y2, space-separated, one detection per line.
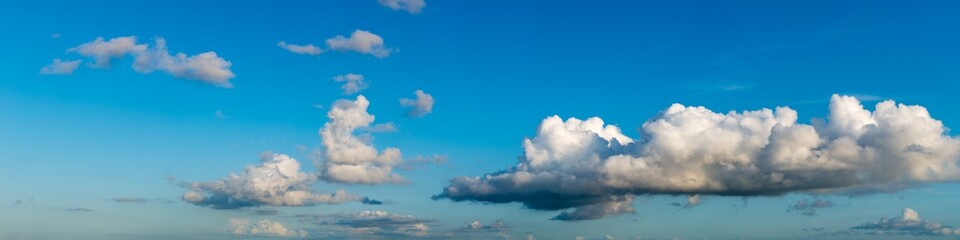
277 29 393 58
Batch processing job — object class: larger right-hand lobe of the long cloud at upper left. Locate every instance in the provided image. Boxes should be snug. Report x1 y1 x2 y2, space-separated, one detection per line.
133 38 235 88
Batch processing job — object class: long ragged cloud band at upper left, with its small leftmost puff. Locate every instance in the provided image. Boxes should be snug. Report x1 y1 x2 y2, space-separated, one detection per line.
53 36 235 88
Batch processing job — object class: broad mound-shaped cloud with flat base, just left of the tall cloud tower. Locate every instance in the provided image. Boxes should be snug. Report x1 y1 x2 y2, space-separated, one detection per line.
180 154 364 209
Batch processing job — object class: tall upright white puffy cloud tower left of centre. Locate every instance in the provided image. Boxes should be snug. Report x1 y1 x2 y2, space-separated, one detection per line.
320 95 404 184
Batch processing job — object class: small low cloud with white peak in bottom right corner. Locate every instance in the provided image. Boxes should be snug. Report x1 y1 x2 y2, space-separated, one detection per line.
853 208 960 235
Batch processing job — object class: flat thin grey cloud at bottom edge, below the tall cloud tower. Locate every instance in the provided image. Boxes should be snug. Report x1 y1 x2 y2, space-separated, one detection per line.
298 211 430 238
